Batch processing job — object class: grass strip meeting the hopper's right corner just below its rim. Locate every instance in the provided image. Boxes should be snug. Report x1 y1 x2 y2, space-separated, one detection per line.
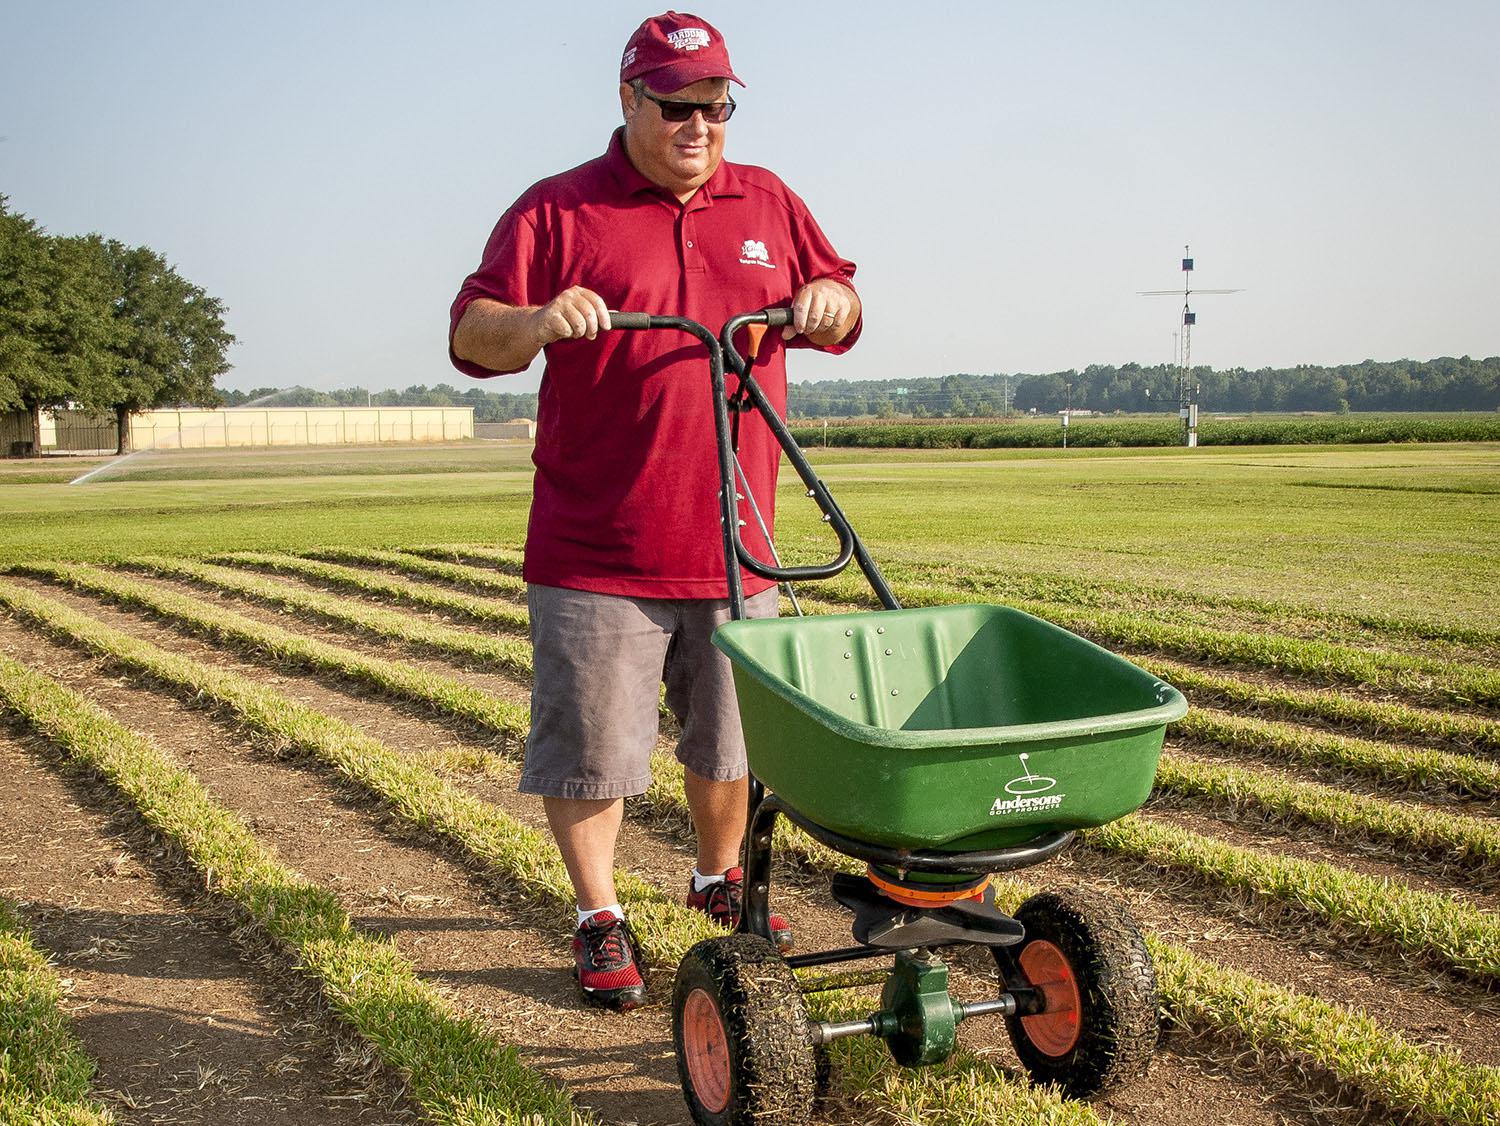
1172 708 1500 798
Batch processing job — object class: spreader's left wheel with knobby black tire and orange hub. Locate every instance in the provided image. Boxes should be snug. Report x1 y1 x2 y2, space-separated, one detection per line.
672 934 818 1126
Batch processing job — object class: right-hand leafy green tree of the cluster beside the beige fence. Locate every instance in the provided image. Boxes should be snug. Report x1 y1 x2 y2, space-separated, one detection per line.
96 238 234 453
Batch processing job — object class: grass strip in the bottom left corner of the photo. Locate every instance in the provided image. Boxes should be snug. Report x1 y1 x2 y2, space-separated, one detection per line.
0 905 114 1126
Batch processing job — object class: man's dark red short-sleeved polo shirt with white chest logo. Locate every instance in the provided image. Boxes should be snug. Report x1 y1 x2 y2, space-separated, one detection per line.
449 130 861 598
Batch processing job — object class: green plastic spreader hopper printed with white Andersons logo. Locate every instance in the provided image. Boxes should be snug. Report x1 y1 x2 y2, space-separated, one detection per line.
714 606 1188 852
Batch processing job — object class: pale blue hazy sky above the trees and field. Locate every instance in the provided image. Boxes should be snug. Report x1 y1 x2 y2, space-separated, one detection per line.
0 0 1500 391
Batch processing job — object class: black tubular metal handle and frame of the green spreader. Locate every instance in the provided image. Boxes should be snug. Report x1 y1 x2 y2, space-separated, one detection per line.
609 309 1074 966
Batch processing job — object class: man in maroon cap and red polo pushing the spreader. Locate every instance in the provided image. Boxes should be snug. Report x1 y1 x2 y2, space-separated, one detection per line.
450 12 860 1009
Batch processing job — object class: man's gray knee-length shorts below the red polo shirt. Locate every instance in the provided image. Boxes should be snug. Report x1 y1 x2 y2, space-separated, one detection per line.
519 585 777 798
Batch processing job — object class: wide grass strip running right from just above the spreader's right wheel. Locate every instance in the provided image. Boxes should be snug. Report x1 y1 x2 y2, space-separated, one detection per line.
1083 814 1500 984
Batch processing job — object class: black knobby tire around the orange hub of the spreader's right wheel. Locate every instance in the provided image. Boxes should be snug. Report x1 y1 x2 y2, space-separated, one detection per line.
996 891 1161 1098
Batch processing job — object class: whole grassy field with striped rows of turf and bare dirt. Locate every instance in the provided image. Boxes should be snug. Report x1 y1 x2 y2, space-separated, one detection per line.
0 442 1500 1126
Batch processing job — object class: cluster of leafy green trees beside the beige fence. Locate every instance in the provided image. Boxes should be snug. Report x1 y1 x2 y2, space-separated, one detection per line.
0 195 234 453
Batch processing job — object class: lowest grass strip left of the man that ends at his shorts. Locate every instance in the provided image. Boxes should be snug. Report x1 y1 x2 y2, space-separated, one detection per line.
26 564 531 739
